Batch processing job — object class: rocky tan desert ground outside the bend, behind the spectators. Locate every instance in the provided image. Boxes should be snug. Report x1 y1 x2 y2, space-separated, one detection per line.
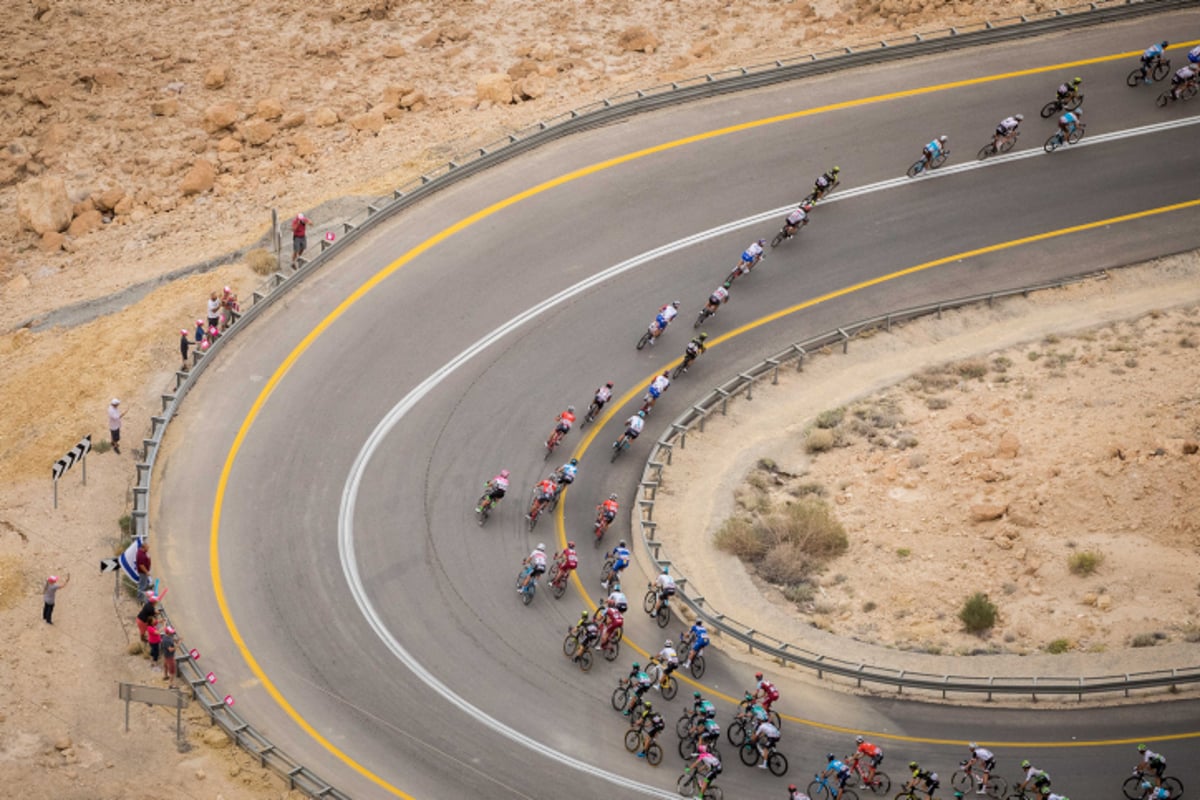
0 0 1180 799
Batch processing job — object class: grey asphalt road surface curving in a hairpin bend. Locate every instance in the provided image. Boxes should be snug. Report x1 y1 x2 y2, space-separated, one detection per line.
152 13 1200 800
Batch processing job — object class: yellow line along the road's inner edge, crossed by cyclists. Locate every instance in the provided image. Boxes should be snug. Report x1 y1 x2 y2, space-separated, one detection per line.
554 199 1200 747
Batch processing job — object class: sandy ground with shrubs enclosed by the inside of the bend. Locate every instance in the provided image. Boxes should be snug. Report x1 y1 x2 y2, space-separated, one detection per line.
654 254 1200 674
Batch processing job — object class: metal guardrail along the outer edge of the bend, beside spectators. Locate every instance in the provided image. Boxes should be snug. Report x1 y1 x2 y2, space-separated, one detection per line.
124 0 1200 798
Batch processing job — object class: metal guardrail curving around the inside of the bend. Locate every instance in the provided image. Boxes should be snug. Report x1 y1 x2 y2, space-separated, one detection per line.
635 272 1200 700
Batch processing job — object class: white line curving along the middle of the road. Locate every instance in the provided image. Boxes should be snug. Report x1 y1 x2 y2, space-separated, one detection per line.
337 116 1200 798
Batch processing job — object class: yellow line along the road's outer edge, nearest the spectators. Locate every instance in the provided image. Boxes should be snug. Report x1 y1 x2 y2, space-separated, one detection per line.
209 50 1194 800
